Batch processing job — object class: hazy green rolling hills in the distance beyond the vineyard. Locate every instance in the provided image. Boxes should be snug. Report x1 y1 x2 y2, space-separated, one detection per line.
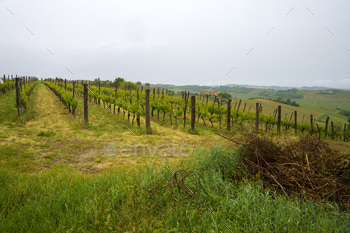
151 84 350 125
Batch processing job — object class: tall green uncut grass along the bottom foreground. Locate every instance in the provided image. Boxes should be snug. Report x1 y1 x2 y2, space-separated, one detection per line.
0 147 350 232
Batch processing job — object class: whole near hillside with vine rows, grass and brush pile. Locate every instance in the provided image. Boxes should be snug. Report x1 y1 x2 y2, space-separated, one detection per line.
0 77 350 232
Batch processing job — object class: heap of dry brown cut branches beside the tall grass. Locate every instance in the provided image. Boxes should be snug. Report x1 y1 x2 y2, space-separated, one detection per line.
241 134 350 209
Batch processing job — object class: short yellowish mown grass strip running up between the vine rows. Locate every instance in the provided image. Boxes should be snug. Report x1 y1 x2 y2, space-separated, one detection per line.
0 82 227 173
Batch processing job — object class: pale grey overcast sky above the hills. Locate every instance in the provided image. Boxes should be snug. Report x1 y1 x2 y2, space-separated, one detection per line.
0 0 350 89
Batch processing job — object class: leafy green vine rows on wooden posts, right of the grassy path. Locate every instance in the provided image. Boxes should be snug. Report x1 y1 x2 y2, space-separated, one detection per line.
44 79 350 141
